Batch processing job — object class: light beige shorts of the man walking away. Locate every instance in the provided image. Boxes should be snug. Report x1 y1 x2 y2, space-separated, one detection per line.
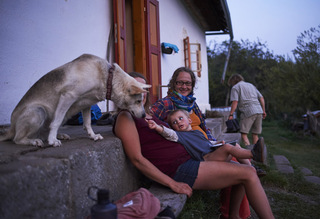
240 114 262 135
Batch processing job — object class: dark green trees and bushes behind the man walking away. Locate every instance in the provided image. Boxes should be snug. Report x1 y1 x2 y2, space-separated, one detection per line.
207 25 320 118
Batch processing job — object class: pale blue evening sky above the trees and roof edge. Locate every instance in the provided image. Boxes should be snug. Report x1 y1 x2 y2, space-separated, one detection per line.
207 0 320 57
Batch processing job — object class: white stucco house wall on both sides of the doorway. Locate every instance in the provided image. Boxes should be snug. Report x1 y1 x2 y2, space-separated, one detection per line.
0 0 210 124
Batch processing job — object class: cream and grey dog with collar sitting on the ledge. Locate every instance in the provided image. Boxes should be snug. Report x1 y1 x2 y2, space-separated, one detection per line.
0 54 151 147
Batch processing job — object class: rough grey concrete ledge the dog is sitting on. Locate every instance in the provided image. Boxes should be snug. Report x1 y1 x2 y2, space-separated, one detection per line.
0 126 140 218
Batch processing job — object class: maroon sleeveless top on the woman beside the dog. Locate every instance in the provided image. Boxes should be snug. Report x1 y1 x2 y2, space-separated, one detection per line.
133 116 191 177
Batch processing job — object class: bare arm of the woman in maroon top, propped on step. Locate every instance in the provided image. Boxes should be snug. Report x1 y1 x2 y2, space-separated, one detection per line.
115 111 192 197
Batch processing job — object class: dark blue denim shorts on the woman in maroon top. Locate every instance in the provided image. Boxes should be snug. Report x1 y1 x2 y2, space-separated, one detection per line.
173 159 200 188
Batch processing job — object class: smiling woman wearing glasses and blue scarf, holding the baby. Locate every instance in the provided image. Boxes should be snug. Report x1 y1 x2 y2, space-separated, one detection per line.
151 67 250 218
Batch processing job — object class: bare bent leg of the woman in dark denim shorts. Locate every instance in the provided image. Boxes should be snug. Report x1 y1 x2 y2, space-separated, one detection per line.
193 161 274 219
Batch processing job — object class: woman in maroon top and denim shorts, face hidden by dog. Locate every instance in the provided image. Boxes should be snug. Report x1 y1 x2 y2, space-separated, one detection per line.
113 74 274 218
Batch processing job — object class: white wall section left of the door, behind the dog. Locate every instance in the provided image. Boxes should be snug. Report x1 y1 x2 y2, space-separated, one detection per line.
0 0 112 124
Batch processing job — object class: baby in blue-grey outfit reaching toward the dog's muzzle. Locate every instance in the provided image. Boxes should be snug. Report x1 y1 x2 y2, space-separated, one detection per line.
146 109 267 164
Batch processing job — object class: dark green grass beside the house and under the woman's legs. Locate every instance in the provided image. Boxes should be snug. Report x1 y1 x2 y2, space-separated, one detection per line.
179 121 320 219
